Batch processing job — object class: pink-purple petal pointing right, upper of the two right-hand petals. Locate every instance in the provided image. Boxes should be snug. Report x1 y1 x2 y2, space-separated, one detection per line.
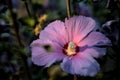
78 32 111 47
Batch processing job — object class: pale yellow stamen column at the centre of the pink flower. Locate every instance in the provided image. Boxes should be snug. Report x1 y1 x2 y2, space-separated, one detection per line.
66 42 76 56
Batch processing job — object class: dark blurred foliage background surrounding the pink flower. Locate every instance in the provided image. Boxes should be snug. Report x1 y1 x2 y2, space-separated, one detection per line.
0 0 120 80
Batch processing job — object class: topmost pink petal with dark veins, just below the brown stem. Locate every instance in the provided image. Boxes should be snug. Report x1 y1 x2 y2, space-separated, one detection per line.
65 16 96 43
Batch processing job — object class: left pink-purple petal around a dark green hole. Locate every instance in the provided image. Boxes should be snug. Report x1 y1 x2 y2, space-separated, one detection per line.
31 39 65 67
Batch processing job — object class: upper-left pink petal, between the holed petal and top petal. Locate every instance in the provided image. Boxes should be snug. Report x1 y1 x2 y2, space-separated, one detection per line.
39 20 68 46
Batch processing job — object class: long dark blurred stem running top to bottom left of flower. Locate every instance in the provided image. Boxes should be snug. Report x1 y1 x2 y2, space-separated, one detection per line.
6 0 31 80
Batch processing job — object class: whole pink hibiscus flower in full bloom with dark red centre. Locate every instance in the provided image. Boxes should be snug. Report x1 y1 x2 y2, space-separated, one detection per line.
31 16 111 76
